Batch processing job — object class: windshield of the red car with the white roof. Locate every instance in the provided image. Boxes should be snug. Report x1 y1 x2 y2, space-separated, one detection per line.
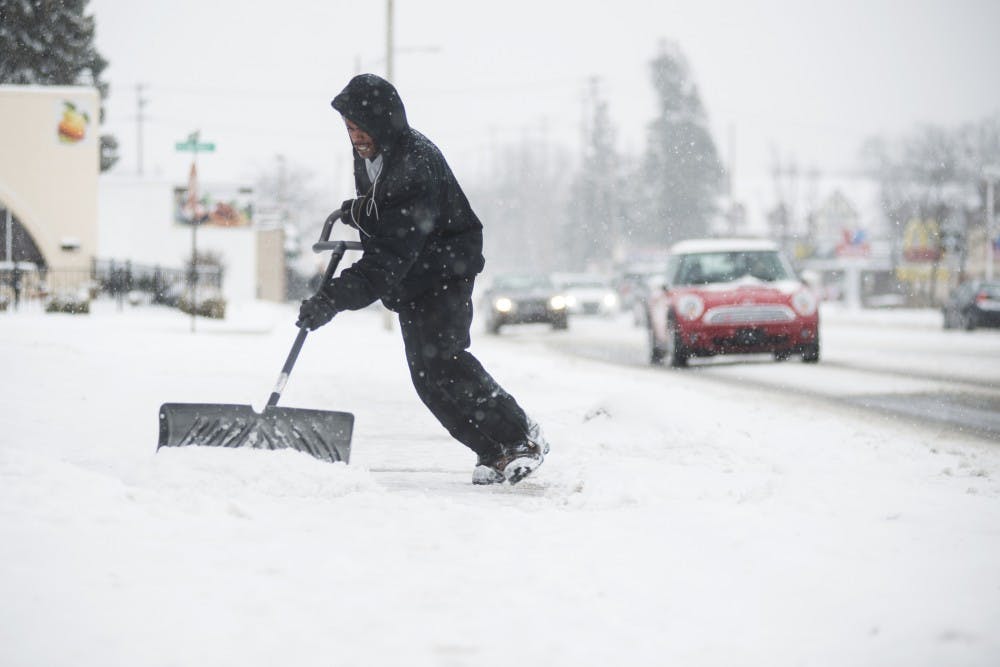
670 250 794 285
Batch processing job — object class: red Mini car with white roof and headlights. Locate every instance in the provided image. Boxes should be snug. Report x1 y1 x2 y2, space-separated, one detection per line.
647 239 820 367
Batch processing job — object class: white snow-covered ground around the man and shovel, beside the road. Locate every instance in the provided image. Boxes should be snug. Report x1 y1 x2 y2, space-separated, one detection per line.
0 303 1000 667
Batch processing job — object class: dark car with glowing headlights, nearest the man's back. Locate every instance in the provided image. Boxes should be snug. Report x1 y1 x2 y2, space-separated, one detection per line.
483 273 569 334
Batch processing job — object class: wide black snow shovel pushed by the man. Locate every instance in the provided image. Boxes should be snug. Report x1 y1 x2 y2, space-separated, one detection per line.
162 211 361 463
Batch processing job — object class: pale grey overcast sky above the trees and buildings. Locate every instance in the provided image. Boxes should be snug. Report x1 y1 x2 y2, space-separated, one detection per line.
89 0 1000 219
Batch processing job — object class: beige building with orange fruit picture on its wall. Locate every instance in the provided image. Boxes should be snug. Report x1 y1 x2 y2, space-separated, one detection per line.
0 86 100 280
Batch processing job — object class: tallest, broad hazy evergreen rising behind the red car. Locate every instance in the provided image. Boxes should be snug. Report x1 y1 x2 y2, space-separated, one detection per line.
633 43 723 243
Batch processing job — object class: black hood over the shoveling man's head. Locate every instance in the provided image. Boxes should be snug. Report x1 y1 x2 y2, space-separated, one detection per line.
330 74 410 151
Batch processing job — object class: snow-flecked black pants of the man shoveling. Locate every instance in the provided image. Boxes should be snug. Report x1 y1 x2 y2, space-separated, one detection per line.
399 279 528 458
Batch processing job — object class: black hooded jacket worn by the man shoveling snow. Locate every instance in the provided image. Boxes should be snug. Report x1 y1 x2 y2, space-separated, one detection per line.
323 74 484 310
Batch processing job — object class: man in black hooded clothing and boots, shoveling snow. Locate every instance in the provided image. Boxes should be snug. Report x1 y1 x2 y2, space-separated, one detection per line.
297 74 548 484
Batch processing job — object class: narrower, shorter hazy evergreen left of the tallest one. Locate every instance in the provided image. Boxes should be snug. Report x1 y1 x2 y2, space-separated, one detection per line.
564 79 626 269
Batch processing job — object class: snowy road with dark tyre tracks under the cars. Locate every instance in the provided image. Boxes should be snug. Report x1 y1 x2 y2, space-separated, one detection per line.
490 307 1000 441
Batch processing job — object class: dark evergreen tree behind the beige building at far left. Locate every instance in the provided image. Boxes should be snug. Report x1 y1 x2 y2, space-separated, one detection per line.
0 0 118 171
